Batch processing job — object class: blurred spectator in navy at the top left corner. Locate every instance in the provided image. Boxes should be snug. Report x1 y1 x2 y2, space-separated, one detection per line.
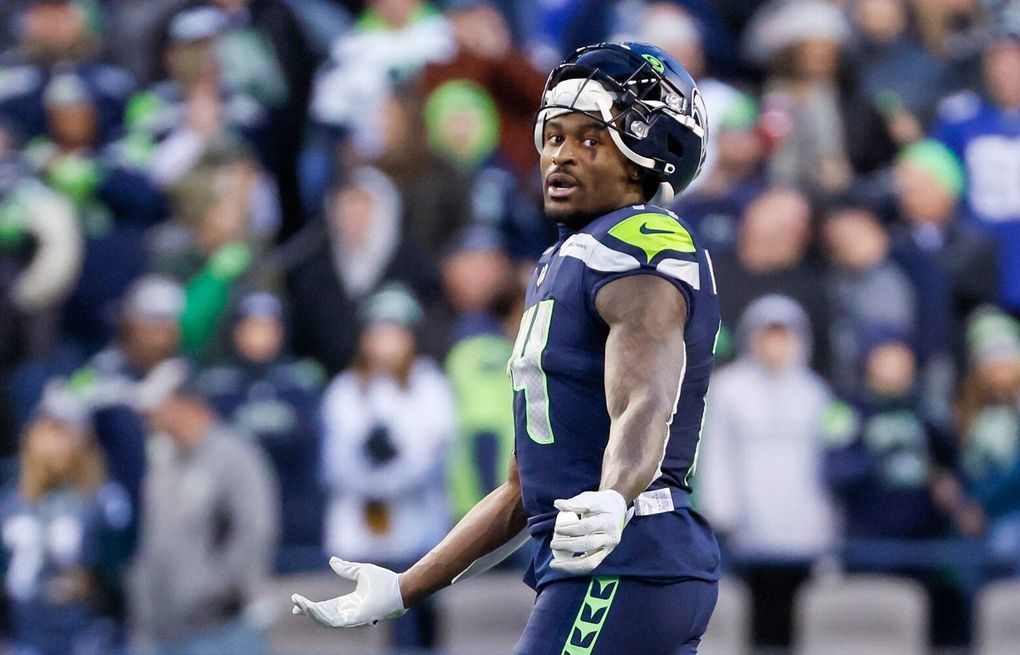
0 0 135 142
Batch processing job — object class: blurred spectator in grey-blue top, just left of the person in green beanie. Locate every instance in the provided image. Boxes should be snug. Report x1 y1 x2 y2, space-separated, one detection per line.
821 204 917 397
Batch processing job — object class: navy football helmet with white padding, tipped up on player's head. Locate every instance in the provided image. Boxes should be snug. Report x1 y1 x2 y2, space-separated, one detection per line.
534 43 708 204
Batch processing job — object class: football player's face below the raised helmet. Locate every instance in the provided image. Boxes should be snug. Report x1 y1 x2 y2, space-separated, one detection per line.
542 112 644 228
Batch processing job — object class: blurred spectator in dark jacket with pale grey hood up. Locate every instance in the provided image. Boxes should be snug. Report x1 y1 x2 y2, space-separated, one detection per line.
290 167 436 375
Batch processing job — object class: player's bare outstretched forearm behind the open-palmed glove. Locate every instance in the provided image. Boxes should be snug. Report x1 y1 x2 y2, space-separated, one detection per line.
400 473 527 607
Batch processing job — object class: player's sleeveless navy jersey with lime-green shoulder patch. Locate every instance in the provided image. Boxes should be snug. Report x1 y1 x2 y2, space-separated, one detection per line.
509 205 719 588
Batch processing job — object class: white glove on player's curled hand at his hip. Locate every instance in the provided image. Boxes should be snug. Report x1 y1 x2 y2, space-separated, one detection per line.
550 489 633 574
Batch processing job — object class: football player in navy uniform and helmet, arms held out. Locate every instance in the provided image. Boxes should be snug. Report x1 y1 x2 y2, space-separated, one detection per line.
292 43 719 655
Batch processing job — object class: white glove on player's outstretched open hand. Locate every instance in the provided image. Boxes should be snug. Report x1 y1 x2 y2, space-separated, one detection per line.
291 557 407 627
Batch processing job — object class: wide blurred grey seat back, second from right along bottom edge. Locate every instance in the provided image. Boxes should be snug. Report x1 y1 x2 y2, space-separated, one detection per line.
794 574 928 655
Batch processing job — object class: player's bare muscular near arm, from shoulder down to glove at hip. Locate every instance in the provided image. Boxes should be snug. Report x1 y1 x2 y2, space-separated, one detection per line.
596 275 687 504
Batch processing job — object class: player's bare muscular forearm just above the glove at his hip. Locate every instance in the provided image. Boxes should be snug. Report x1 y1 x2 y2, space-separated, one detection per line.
599 395 672 504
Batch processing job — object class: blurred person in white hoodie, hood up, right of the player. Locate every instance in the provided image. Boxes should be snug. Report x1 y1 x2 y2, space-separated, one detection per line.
698 295 835 647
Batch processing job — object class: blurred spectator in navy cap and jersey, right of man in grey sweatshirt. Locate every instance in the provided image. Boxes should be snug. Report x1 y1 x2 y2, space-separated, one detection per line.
195 292 323 550
